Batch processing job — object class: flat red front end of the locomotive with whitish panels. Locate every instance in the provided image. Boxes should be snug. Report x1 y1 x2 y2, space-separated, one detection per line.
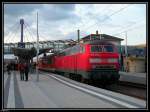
88 44 120 84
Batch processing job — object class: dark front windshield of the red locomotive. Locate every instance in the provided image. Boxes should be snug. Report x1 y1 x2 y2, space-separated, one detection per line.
91 45 114 52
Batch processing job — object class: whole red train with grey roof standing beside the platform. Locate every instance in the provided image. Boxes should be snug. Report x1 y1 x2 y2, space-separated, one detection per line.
38 40 120 84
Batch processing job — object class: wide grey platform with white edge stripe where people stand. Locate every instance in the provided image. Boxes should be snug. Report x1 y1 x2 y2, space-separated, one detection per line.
3 71 146 110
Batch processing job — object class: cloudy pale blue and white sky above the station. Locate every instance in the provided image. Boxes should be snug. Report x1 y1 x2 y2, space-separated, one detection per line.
4 4 146 45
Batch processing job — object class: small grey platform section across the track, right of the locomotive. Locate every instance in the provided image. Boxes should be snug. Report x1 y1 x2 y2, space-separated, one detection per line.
119 71 147 85
